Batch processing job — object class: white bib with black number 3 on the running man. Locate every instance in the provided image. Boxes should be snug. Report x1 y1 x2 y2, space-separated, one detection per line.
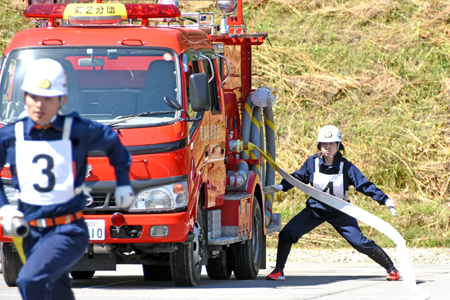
15 118 75 205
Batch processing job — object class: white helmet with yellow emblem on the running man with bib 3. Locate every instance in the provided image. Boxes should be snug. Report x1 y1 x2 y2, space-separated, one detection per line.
22 58 67 97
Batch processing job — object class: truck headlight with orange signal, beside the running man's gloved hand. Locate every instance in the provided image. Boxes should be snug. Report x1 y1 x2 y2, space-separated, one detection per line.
129 181 188 212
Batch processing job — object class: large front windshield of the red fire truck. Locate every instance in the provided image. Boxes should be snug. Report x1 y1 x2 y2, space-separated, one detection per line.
0 47 180 127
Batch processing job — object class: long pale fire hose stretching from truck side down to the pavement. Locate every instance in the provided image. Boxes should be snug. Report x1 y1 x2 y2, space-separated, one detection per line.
244 143 431 300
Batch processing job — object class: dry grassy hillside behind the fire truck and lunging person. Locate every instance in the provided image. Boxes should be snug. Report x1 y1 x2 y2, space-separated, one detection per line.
0 0 450 247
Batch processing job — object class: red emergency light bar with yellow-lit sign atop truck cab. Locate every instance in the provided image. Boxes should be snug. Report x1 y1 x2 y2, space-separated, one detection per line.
24 3 181 24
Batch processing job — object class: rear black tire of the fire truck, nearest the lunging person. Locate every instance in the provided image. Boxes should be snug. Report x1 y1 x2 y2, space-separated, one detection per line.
231 199 263 280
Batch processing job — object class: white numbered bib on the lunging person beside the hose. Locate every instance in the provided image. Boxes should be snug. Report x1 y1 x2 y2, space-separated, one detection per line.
313 158 345 199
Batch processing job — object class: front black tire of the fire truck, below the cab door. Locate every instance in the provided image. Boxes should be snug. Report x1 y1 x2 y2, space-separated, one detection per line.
170 202 208 286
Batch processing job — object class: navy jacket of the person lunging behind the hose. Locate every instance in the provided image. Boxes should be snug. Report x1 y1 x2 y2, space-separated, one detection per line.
281 152 389 214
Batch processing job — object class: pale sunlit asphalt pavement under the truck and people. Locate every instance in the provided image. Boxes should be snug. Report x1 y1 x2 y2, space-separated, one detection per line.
0 262 450 300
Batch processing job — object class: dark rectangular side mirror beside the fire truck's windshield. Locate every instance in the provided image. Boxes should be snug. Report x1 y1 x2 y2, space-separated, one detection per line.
189 73 211 112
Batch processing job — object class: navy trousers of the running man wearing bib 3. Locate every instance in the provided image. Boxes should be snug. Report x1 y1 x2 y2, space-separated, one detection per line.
17 219 89 300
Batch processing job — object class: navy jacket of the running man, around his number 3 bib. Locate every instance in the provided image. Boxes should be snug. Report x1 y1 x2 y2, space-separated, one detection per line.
0 112 131 221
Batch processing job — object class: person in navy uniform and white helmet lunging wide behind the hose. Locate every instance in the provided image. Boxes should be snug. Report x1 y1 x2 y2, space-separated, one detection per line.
264 125 400 281
